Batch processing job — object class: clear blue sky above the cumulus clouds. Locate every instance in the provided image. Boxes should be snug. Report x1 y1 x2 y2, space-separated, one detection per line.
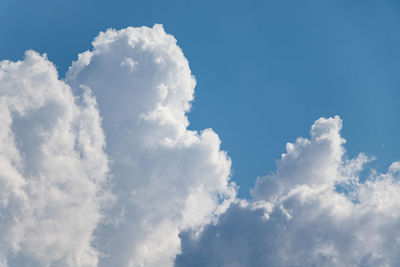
0 0 400 196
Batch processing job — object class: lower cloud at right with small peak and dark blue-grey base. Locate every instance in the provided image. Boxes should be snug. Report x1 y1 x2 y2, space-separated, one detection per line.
176 117 400 266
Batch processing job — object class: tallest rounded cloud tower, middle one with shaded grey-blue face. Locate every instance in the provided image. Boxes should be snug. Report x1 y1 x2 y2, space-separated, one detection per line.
67 25 235 266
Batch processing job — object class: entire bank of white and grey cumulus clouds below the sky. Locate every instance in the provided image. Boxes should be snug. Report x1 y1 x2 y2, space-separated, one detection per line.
0 25 400 266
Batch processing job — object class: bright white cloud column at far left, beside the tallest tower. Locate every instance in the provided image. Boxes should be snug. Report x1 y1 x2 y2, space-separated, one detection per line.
0 51 108 266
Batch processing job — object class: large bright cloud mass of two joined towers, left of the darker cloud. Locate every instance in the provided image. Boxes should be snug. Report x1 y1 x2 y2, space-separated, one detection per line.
0 25 236 266
